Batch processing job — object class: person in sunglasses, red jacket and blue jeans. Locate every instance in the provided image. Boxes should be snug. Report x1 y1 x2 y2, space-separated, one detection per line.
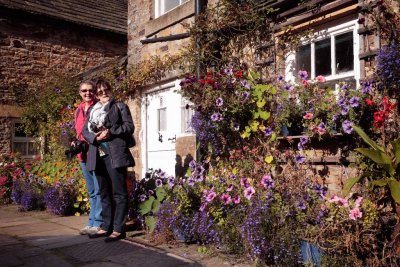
73 81 103 235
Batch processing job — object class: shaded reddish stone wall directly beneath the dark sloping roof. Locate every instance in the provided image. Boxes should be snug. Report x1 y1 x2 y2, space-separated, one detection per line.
0 11 126 88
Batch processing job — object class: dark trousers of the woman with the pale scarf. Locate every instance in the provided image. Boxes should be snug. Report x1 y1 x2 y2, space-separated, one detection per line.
95 155 128 233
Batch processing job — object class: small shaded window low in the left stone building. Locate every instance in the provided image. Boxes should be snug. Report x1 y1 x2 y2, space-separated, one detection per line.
12 121 38 158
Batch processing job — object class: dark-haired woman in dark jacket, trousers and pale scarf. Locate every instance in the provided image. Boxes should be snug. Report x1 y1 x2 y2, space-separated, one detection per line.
82 80 134 242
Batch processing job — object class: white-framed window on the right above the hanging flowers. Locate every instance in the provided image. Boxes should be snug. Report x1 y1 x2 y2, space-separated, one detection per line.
285 20 359 83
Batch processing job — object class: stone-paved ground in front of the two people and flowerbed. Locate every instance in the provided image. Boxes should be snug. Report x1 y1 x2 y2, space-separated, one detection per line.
0 205 250 267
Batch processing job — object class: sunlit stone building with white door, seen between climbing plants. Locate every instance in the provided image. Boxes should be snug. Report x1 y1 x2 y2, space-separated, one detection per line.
128 0 398 186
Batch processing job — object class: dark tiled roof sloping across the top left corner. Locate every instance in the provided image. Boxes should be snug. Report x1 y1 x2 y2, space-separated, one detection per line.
0 0 128 34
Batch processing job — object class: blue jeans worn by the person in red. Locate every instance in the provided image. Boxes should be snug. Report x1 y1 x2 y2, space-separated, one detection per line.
81 162 103 227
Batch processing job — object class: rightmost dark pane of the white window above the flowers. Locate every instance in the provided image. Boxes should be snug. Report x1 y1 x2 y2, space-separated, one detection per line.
335 32 354 73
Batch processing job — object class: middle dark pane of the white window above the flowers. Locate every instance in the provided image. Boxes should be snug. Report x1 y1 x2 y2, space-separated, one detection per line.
315 39 332 76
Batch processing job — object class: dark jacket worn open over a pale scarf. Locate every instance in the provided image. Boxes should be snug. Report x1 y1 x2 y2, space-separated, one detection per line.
82 100 135 171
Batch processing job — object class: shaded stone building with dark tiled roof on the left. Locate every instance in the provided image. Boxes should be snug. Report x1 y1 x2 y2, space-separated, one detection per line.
0 0 127 156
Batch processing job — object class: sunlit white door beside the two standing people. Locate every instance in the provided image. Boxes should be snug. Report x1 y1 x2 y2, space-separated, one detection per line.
145 81 181 178
